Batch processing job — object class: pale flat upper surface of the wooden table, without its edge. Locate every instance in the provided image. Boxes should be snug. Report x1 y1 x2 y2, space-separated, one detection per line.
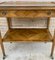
0 1 55 7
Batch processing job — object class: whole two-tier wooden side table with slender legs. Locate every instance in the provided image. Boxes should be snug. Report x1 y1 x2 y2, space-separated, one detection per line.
0 2 55 59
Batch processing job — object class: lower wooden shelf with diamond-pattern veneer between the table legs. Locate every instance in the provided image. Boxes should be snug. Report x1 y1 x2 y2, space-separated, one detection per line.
3 29 52 42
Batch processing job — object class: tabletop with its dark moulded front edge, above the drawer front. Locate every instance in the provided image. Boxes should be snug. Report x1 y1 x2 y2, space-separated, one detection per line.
0 1 55 10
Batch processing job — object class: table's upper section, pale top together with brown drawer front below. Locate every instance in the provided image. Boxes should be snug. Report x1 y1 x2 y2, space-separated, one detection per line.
0 1 55 18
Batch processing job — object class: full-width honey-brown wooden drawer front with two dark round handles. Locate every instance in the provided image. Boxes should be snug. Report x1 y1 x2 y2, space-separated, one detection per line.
0 10 55 18
